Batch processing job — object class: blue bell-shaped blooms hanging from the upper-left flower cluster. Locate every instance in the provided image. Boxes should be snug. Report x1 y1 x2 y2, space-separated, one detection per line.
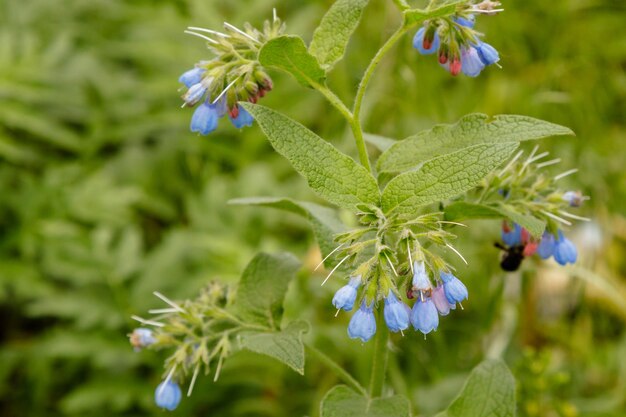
178 67 254 135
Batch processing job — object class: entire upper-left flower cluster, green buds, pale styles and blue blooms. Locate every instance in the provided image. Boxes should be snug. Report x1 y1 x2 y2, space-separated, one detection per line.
178 14 284 135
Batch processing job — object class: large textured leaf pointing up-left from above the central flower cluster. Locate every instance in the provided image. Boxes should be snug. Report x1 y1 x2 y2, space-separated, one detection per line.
242 103 380 209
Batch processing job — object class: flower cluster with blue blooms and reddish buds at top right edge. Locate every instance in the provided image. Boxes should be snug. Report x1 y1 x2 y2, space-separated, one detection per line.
413 1 502 77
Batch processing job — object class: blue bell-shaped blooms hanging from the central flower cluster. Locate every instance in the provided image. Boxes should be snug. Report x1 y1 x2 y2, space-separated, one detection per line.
332 261 468 342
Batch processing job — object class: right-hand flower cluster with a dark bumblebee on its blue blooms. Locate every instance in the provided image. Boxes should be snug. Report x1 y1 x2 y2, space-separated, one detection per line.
479 148 589 271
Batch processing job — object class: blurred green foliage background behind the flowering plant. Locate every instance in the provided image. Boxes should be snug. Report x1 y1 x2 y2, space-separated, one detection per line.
0 0 626 417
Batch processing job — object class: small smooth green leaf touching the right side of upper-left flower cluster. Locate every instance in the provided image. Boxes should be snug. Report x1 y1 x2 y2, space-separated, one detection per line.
259 35 326 87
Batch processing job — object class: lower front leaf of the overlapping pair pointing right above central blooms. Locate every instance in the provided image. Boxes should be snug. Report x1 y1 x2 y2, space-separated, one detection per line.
382 142 518 216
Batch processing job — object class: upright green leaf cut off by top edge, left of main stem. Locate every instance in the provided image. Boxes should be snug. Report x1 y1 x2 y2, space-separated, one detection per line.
309 0 369 70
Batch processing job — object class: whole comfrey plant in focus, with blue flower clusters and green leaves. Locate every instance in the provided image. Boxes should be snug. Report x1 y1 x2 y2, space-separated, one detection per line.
130 0 586 416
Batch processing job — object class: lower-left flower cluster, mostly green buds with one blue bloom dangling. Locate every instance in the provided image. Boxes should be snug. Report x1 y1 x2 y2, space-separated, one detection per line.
128 282 239 411
